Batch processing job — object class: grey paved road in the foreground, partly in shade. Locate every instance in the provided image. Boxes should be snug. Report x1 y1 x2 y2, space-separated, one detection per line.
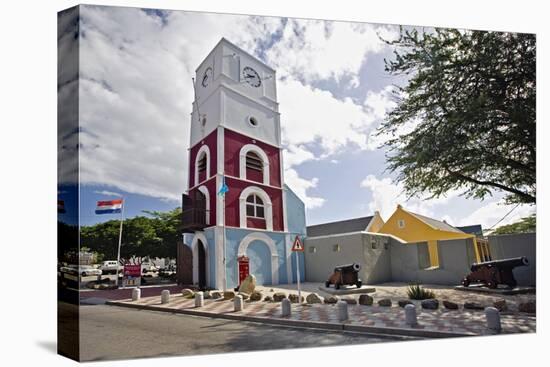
80 305 406 361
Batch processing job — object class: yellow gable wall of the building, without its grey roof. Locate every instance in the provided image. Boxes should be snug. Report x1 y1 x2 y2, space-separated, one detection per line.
379 206 478 266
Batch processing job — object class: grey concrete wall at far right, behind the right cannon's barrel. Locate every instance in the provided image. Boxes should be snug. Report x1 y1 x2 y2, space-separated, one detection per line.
489 233 537 286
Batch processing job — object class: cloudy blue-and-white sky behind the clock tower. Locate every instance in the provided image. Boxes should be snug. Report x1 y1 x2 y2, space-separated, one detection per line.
62 6 534 228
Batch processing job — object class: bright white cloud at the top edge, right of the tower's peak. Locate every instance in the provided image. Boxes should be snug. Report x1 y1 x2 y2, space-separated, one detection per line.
266 19 396 87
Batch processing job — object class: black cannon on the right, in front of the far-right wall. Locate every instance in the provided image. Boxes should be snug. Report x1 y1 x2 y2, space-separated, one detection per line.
462 256 529 289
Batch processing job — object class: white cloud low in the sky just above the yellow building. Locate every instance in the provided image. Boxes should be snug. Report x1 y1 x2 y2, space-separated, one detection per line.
360 175 460 223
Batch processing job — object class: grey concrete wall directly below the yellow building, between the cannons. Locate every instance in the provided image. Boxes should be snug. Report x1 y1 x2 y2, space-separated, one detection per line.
391 240 473 285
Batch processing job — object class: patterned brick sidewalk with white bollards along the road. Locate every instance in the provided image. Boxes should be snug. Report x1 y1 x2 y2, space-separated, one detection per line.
107 294 536 338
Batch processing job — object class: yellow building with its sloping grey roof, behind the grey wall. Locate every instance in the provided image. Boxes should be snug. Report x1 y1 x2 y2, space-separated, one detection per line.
371 205 491 267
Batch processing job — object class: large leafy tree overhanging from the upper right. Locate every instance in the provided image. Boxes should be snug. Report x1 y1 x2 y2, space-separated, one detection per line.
378 29 536 204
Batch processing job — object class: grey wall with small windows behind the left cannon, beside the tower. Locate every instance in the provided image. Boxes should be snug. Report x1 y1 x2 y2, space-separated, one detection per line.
305 233 391 284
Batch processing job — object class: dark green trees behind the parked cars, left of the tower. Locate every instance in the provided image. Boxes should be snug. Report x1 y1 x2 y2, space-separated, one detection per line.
80 208 181 260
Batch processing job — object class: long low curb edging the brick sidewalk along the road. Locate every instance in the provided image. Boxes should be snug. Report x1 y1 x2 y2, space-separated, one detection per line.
105 301 477 338
